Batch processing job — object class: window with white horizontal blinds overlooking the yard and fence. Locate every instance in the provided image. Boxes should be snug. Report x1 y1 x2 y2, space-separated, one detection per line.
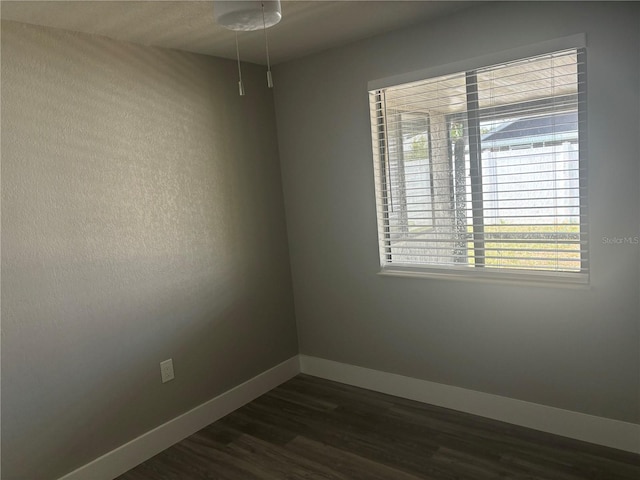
369 49 588 282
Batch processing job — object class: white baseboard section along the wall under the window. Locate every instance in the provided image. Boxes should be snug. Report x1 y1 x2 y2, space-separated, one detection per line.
300 355 640 453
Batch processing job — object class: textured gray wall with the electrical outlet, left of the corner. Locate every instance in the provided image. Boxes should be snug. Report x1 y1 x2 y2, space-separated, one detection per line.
2 22 297 480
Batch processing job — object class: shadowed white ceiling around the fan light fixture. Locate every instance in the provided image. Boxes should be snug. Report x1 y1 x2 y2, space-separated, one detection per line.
1 0 474 64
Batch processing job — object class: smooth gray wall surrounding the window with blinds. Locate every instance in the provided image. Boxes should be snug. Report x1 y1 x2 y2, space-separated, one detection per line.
274 2 640 422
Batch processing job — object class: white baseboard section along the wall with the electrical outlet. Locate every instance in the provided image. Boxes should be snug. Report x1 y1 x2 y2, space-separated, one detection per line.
59 355 300 480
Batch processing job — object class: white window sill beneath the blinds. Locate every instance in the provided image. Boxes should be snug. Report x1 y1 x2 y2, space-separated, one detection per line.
378 266 591 290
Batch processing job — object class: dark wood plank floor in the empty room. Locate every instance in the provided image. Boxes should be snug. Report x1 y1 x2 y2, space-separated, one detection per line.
118 375 640 480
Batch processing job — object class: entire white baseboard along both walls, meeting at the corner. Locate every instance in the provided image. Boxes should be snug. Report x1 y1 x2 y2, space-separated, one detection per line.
59 355 640 480
